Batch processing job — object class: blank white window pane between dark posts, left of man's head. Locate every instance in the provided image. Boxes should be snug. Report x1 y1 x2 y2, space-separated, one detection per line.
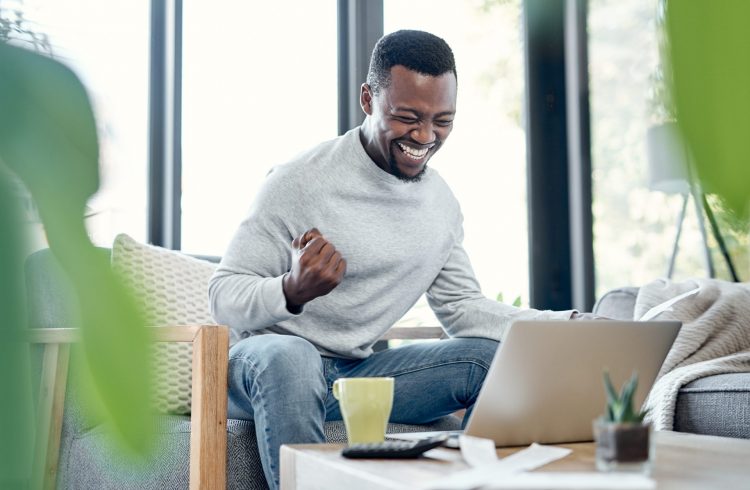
182 0 338 255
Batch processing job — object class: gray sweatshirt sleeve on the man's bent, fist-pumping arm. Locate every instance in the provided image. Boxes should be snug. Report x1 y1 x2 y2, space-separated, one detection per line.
208 167 302 331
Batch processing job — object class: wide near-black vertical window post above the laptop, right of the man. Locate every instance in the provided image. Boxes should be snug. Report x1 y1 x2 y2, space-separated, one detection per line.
524 0 572 310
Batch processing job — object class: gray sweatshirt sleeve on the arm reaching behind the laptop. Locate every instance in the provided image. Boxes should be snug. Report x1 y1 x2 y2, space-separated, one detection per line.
427 222 574 340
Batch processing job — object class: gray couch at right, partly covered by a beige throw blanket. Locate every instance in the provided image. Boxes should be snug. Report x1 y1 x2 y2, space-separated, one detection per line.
594 287 750 439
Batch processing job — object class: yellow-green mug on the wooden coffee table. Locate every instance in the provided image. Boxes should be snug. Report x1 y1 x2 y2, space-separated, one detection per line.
333 378 393 444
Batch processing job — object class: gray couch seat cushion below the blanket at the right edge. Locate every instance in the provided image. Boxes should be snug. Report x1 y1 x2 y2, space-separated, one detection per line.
674 373 750 439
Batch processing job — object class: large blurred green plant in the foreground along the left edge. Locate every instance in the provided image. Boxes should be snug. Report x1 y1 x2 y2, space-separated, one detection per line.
0 41 153 488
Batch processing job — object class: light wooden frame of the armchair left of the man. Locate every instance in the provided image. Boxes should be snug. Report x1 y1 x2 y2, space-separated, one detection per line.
28 325 229 489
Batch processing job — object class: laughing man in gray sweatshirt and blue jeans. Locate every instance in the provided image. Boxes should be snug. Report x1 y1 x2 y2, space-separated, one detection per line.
209 31 572 488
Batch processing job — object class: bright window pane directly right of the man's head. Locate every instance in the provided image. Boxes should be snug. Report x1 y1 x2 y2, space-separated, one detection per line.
384 0 529 325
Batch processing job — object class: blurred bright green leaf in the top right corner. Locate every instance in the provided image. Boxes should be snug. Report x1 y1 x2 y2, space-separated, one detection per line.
666 0 750 223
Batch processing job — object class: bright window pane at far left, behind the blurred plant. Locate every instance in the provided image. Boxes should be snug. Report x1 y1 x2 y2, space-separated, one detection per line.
9 0 149 248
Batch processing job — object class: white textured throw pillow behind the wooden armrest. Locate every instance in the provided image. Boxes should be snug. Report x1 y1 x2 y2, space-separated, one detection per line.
112 234 216 415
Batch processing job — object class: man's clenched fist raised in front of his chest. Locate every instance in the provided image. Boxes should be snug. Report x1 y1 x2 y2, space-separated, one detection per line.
282 228 346 313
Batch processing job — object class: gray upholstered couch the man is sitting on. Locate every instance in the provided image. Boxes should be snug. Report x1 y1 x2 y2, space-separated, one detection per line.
26 250 461 490
